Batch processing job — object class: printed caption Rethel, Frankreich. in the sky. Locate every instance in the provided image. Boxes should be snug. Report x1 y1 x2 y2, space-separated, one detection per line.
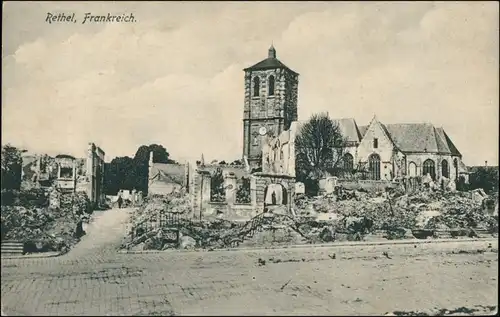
45 12 137 24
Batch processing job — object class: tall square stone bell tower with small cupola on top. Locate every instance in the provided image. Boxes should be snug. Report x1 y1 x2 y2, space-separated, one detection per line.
243 46 299 167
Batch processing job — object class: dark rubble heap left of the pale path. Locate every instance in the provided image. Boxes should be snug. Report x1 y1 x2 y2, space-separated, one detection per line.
1 189 91 252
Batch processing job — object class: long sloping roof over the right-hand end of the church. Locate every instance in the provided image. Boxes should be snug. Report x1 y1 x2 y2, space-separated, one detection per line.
382 123 461 156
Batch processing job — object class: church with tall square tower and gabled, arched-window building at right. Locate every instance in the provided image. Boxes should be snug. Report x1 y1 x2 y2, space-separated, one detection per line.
243 46 467 180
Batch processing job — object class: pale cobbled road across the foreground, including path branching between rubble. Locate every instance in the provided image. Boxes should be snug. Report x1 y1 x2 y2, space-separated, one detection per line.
1 209 498 316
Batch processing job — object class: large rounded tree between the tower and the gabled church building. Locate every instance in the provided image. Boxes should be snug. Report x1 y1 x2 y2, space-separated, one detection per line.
295 113 346 183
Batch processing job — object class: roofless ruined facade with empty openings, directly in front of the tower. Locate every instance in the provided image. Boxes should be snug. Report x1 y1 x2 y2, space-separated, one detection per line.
189 122 297 220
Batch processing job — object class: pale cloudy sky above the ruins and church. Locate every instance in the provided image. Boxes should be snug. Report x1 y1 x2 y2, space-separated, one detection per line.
2 1 499 165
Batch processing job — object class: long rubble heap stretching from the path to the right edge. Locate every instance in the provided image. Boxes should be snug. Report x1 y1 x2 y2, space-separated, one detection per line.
123 188 498 250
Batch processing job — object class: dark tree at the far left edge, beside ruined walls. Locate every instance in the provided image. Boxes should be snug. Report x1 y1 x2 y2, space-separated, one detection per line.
1 144 23 189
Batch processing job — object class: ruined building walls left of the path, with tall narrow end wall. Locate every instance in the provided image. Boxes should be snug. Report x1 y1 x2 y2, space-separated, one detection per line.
21 143 105 206
